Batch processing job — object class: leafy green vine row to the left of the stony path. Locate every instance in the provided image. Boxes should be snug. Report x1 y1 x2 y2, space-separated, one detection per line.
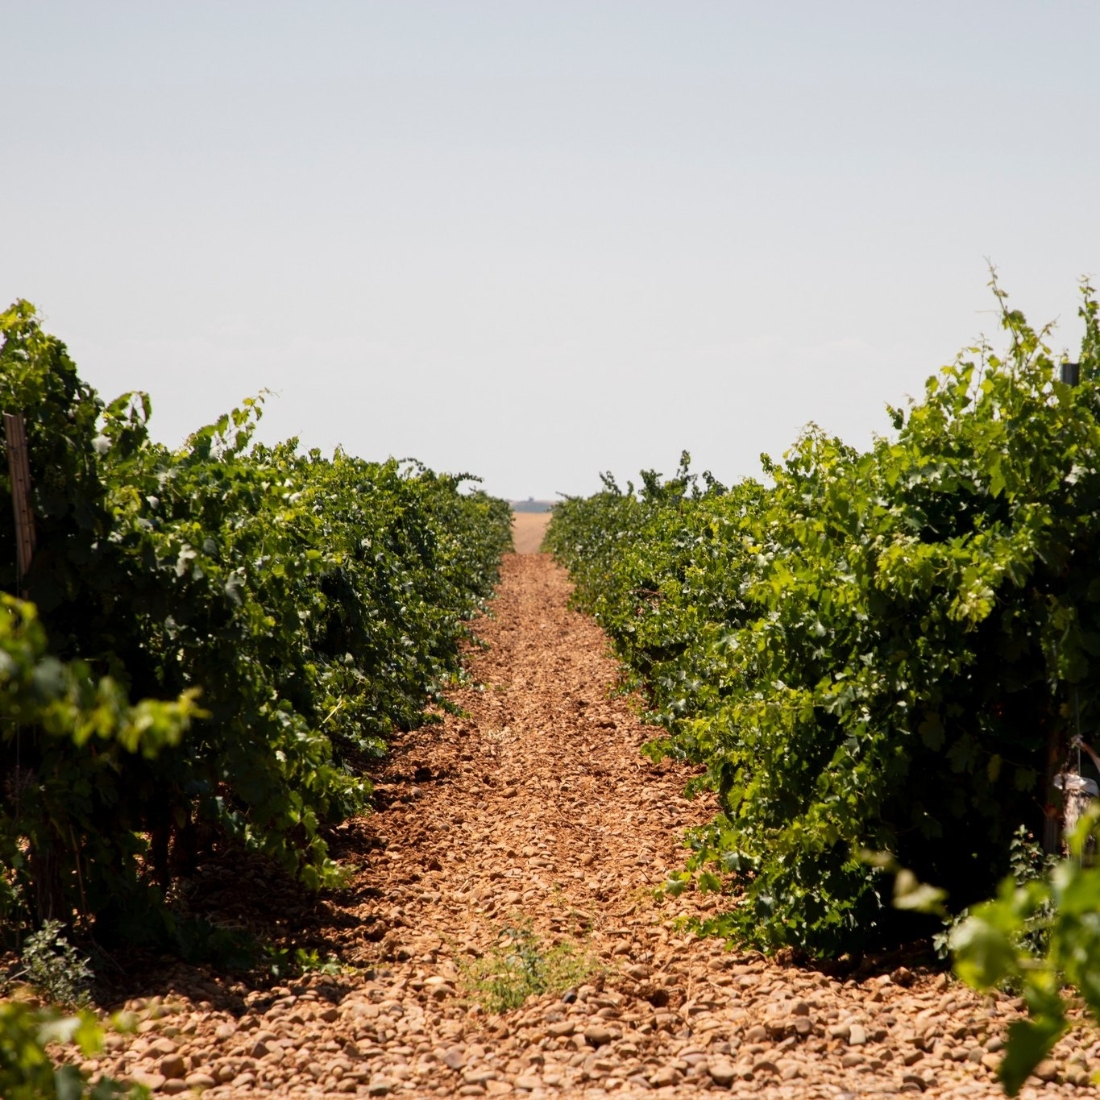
0 303 510 946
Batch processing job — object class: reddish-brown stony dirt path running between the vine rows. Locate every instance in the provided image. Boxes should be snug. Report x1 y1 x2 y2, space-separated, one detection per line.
81 554 1100 1100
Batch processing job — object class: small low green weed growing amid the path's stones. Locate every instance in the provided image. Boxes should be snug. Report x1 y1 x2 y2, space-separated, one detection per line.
459 921 600 1013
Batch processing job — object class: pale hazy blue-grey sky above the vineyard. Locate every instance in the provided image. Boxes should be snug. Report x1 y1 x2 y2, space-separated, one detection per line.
0 0 1100 497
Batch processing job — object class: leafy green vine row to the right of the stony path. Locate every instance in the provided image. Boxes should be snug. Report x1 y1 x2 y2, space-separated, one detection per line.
548 287 1100 956
